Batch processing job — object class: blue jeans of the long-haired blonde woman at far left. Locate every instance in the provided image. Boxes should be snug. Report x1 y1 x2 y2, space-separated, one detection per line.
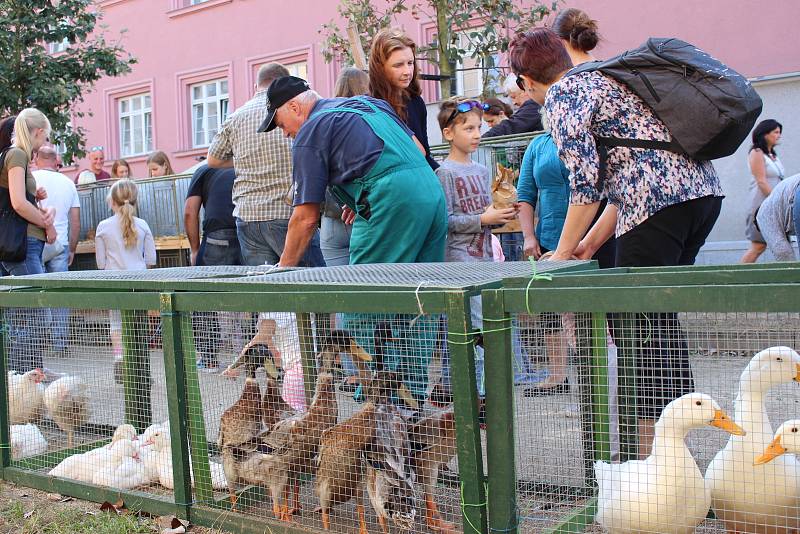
0 237 47 373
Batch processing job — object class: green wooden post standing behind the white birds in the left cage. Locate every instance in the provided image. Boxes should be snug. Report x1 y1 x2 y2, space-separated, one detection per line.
121 310 153 432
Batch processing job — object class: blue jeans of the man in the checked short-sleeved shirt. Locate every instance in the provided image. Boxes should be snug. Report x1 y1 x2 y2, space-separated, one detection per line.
236 219 325 267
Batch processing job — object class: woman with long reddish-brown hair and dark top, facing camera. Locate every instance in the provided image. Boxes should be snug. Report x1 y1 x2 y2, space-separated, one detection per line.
369 28 439 170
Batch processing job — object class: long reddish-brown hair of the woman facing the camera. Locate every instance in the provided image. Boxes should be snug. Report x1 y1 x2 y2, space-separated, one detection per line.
369 28 422 121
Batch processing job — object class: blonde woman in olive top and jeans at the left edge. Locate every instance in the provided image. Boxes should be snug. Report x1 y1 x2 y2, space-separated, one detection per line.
0 108 56 373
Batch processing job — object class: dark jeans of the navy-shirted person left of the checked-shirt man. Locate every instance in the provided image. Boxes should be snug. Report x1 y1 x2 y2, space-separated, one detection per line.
192 228 242 367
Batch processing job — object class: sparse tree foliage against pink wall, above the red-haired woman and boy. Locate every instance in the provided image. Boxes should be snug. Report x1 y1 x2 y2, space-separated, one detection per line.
320 0 560 98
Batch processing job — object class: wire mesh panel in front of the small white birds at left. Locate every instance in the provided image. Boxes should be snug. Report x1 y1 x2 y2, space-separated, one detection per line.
3 308 171 499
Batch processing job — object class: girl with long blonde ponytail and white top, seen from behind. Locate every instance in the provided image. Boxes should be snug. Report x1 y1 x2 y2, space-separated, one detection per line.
94 179 156 375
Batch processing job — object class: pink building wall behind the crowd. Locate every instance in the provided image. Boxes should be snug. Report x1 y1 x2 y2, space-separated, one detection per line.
68 0 800 180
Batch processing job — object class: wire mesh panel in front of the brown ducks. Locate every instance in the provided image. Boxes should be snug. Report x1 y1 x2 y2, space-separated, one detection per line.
184 311 460 532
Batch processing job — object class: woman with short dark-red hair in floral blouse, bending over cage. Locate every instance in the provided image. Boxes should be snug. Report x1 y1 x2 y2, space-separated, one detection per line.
509 28 723 456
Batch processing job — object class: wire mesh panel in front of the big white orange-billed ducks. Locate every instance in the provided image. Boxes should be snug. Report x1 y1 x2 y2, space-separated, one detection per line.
484 273 800 533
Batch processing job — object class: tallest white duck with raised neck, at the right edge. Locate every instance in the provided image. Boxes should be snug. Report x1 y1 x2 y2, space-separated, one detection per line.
706 347 800 534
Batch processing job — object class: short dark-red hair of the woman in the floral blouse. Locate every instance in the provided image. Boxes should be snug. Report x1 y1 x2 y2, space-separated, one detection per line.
508 28 573 84
